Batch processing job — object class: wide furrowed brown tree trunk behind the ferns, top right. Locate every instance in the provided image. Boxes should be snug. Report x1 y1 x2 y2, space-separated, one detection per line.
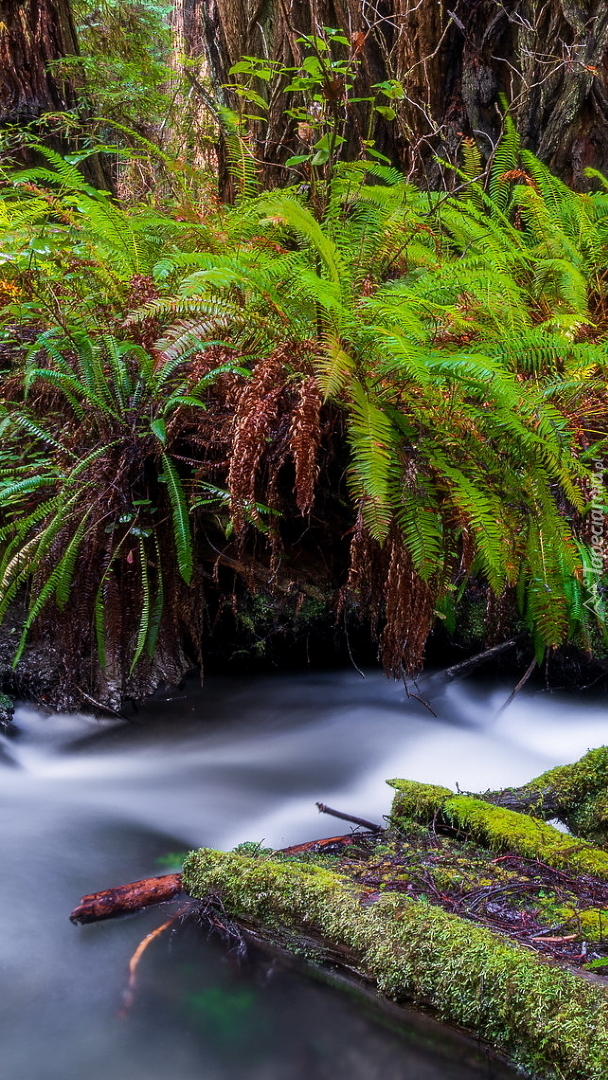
184 0 608 187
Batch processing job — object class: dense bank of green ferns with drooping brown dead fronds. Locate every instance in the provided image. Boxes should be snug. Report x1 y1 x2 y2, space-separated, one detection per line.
0 118 608 705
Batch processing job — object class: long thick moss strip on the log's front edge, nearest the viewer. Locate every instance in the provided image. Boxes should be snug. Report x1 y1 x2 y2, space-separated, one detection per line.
184 849 608 1080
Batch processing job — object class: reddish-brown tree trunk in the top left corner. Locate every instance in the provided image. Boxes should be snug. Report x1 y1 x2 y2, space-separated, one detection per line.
0 0 111 188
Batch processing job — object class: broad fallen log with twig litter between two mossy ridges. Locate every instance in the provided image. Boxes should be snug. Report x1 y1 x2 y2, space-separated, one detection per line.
183 764 608 1080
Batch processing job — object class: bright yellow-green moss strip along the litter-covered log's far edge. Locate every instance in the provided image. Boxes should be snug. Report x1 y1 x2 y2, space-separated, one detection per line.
388 780 608 881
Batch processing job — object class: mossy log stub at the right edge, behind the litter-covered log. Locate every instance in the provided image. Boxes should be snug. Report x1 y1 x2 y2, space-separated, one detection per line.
483 746 608 847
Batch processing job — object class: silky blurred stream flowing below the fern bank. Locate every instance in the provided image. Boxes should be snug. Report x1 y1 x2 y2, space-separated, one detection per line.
0 672 608 1080
